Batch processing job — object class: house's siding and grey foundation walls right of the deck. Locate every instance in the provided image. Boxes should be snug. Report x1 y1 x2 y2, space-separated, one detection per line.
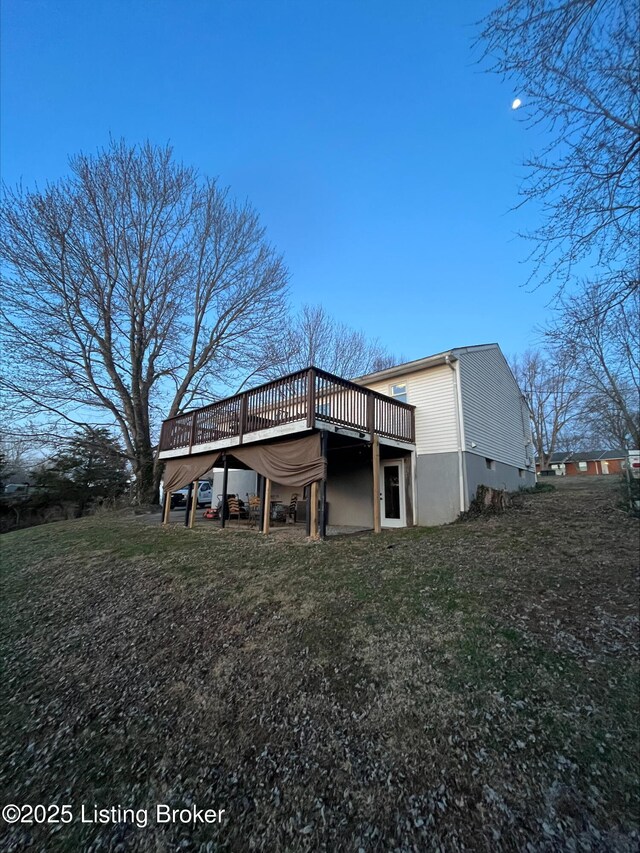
360 345 536 526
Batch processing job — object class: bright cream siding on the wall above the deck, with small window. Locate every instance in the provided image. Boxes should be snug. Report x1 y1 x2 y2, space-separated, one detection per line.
366 364 458 454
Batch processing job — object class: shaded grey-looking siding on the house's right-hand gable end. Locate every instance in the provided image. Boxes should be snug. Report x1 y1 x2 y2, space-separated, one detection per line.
455 346 532 468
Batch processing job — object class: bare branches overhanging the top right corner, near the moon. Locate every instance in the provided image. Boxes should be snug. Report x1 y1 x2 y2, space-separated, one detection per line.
480 0 640 308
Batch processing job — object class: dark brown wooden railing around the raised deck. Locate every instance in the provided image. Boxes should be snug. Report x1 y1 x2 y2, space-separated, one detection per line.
160 367 415 452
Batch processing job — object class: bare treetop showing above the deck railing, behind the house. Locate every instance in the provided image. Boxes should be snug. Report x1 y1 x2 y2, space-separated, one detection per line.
255 305 397 378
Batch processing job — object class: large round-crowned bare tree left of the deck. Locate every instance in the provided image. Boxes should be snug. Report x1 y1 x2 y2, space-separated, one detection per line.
0 141 288 501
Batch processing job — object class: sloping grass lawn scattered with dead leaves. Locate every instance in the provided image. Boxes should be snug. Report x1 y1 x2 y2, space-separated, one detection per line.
0 477 640 853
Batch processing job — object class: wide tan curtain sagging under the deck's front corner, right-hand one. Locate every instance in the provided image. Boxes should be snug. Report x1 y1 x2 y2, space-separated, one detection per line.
227 433 327 488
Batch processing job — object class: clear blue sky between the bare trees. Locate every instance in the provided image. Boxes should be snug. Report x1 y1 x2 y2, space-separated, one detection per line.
1 0 552 359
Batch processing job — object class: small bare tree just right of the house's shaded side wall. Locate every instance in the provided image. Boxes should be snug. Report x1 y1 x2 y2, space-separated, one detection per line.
510 350 580 471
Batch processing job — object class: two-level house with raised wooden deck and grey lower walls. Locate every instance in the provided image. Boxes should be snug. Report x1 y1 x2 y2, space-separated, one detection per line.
160 344 535 535
